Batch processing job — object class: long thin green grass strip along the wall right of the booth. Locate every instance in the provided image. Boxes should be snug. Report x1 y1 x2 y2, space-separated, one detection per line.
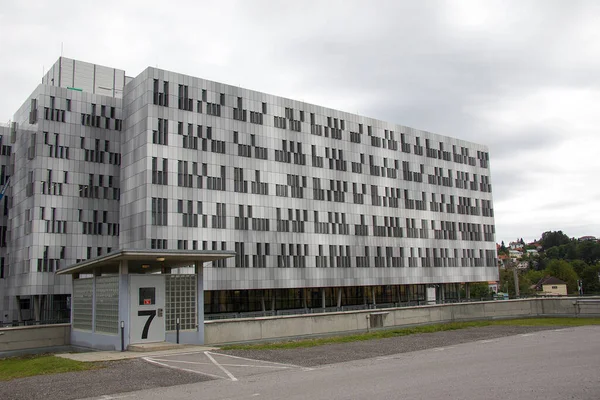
221 318 600 350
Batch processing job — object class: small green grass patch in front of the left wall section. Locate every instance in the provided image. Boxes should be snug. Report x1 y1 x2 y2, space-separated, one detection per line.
0 355 99 381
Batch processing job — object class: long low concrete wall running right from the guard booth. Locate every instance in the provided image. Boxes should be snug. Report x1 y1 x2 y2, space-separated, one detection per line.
204 297 600 345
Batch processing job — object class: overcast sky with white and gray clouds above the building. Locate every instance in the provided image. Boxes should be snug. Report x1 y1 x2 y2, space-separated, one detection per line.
0 0 600 243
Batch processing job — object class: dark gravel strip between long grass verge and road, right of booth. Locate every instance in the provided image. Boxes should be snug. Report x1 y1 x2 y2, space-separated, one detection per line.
219 326 561 367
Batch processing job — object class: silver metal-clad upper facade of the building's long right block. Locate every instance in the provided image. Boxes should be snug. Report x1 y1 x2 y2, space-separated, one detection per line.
120 68 497 290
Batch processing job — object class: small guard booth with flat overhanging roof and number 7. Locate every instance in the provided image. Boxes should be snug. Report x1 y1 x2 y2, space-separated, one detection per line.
56 250 235 350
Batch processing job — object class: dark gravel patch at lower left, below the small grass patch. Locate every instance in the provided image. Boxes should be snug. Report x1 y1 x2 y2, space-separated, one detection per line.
0 359 212 400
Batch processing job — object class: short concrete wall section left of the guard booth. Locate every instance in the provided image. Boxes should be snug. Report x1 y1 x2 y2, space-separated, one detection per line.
0 324 71 352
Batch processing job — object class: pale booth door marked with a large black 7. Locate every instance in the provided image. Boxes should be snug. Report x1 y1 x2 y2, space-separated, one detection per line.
129 275 165 343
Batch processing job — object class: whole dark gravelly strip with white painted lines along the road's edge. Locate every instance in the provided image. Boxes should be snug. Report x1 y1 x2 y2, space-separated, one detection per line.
0 326 560 400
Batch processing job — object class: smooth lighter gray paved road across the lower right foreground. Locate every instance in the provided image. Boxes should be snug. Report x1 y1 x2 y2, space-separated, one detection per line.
79 326 600 400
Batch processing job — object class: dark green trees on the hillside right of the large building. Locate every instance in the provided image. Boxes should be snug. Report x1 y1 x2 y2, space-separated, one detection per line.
498 231 600 296
